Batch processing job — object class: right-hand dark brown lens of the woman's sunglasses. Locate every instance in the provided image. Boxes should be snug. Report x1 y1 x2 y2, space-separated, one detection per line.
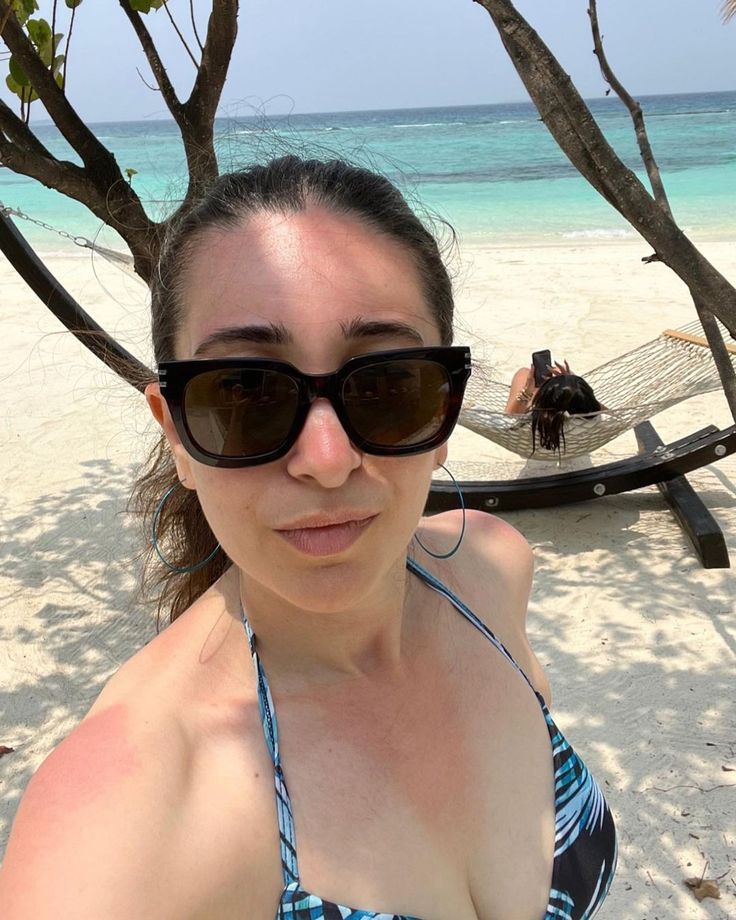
342 358 451 447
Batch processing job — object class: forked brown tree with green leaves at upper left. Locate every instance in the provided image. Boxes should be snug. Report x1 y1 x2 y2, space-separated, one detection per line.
0 0 238 281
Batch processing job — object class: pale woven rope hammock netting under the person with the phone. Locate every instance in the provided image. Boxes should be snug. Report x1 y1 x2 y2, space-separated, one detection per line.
460 322 736 462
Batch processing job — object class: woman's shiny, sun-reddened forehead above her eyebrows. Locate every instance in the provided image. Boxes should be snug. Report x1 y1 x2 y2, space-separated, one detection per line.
177 206 439 357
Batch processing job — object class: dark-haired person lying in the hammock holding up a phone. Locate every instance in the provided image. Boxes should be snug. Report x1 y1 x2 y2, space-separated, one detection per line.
504 361 606 452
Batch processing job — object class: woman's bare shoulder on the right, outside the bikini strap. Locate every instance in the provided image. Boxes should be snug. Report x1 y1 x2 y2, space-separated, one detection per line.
422 510 551 703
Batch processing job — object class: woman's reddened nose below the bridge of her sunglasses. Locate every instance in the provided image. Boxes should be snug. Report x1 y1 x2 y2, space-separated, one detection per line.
287 398 362 489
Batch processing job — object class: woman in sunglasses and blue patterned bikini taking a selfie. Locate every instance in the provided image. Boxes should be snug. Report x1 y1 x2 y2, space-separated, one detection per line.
0 157 615 920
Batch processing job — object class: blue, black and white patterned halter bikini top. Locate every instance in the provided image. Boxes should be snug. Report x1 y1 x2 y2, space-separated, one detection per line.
241 559 617 920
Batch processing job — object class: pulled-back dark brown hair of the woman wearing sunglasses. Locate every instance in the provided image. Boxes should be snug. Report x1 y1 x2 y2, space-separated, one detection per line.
131 156 454 622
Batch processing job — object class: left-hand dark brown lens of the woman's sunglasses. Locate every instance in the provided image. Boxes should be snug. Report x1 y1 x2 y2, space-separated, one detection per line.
183 369 299 458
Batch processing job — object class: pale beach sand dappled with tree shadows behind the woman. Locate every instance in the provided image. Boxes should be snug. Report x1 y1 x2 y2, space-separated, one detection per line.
0 242 736 920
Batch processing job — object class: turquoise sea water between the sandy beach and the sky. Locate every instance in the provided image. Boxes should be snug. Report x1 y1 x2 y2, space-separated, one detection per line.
0 92 736 250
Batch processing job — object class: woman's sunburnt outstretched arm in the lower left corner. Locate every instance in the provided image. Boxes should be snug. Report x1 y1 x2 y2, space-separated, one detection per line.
0 703 188 920
